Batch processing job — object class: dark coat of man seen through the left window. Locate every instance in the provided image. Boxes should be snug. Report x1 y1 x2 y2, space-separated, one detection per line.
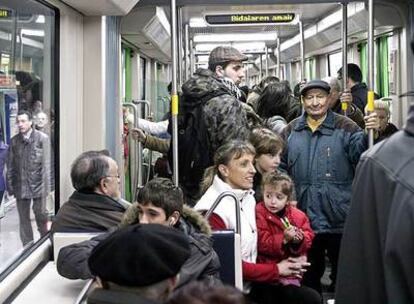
6 130 51 199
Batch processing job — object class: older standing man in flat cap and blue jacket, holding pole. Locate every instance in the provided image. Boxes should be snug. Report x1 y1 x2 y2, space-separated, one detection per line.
281 80 379 292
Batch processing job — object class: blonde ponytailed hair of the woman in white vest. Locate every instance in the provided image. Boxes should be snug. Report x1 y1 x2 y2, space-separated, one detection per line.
200 140 256 194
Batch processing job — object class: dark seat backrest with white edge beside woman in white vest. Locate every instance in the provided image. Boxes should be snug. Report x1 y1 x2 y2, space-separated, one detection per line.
212 230 243 290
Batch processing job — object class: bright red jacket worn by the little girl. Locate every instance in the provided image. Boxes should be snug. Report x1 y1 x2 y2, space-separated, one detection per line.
256 202 314 263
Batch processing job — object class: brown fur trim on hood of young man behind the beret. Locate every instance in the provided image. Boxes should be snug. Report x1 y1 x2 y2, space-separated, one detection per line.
120 203 211 236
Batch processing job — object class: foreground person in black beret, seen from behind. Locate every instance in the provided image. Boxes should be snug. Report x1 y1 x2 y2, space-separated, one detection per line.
88 224 190 304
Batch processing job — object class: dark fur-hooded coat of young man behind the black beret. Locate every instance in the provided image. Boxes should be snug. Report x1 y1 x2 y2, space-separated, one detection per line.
57 203 220 287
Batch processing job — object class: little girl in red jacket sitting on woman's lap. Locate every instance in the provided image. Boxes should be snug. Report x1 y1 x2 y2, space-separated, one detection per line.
256 172 314 286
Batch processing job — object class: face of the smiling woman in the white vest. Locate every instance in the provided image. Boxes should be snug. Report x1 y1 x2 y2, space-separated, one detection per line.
219 154 256 190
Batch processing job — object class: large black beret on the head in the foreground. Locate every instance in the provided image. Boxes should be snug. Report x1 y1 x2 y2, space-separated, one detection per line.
88 224 190 287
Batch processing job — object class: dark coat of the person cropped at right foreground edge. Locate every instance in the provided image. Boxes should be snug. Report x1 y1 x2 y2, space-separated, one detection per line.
335 105 414 304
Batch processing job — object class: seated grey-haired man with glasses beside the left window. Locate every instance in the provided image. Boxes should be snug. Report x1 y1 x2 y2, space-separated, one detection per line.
51 150 129 233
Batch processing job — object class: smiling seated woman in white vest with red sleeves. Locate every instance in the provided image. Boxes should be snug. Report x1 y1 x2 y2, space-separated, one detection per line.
194 141 320 303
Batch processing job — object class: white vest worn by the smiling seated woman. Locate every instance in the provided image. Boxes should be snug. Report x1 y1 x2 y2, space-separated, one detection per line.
194 175 257 263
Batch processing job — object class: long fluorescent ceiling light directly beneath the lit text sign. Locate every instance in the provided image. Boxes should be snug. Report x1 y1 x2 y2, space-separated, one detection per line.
194 32 277 42
